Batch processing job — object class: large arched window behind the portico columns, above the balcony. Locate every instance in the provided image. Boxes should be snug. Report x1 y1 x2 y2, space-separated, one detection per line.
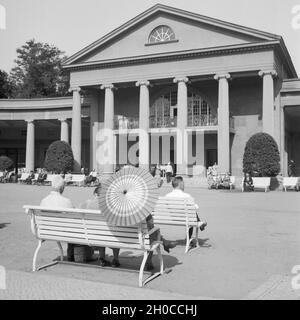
150 89 217 128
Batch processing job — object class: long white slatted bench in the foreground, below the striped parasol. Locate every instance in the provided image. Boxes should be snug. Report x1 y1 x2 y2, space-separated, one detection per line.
23 206 164 287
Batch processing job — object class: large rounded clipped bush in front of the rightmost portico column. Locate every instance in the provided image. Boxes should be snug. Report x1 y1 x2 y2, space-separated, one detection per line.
243 132 280 177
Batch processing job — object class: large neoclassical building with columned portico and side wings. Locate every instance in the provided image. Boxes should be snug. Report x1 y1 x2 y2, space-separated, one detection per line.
0 4 300 175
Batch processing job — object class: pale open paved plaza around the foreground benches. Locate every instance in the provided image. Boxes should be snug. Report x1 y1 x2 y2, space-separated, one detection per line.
0 184 300 299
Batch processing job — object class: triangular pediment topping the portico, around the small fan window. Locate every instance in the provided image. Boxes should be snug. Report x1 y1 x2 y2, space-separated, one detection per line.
65 5 281 66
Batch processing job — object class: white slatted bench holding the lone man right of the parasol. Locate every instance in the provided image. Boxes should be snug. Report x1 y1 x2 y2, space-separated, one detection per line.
152 197 200 253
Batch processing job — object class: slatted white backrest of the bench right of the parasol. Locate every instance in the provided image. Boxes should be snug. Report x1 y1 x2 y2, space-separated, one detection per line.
152 197 197 225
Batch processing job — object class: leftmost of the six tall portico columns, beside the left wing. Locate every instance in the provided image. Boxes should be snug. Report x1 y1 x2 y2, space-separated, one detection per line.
71 88 82 172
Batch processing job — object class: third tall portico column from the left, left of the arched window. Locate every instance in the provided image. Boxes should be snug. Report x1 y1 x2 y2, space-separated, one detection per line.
136 81 150 170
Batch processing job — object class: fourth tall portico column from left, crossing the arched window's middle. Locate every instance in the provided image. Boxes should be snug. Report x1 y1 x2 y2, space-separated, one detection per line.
173 77 189 176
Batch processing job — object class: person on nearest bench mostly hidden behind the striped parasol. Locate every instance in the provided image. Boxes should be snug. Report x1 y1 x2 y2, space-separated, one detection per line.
79 185 120 268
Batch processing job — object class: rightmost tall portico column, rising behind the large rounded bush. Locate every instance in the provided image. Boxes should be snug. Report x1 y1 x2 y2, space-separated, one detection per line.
258 70 277 137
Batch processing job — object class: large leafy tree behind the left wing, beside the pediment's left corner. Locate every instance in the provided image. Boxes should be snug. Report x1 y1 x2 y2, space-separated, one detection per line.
10 39 68 98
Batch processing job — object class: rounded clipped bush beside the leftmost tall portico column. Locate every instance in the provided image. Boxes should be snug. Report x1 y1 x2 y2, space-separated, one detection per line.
44 141 74 173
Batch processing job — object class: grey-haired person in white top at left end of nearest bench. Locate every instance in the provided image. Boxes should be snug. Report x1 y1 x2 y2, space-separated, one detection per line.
40 175 74 261
